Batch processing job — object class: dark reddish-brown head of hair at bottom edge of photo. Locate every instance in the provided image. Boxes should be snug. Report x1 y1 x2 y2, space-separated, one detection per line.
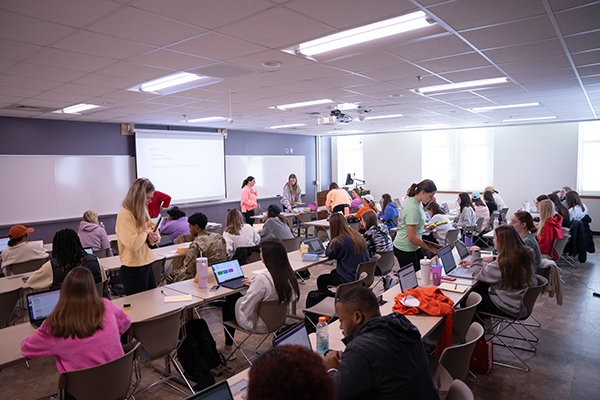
248 344 336 400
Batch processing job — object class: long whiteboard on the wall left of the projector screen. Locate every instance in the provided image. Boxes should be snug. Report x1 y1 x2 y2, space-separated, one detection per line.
0 155 135 225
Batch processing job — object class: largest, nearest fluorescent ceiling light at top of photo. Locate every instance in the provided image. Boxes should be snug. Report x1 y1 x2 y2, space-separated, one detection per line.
284 11 432 56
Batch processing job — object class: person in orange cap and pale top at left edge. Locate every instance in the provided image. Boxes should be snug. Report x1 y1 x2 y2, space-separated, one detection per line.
1 225 48 276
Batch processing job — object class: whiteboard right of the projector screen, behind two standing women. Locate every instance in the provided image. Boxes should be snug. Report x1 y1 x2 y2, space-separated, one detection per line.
225 156 306 200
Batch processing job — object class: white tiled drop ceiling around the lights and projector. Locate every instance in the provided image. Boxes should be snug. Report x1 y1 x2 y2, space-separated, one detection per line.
0 0 600 135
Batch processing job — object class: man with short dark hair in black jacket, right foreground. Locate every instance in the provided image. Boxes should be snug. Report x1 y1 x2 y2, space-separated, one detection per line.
323 287 438 400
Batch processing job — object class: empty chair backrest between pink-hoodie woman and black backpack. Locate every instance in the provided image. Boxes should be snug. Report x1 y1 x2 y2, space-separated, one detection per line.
131 307 183 360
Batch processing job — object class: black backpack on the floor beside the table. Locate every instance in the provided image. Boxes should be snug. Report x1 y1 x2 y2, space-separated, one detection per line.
177 319 225 391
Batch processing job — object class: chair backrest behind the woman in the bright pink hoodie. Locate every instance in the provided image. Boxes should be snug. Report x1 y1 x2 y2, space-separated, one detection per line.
58 343 141 400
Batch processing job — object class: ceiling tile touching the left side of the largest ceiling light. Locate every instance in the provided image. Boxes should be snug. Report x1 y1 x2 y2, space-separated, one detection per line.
217 7 335 49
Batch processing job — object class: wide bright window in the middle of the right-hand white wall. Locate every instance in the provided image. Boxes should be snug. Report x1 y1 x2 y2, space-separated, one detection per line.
421 128 494 191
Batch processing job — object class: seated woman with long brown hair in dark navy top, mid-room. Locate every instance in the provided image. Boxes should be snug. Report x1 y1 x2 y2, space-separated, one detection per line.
317 213 371 296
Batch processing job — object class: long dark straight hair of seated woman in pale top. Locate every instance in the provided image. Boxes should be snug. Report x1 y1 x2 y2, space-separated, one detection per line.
260 237 300 303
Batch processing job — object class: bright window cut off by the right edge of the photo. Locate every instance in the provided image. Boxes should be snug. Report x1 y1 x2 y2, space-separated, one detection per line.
577 121 600 196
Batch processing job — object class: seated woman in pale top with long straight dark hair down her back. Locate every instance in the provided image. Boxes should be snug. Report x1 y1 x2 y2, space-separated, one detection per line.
220 238 300 360
